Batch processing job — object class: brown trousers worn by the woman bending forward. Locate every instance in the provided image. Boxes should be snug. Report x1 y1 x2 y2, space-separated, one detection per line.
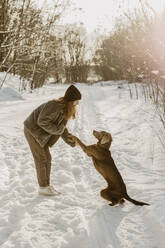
24 127 51 187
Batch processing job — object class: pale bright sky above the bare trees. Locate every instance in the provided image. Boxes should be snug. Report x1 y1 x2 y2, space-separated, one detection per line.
39 0 165 32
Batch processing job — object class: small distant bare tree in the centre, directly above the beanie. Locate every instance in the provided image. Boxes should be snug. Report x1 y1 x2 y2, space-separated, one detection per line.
63 25 90 82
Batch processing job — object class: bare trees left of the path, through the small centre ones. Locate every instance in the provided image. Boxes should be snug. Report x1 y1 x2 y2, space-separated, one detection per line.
0 0 89 90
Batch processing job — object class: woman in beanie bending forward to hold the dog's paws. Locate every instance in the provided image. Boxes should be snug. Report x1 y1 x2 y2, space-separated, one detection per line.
24 85 81 196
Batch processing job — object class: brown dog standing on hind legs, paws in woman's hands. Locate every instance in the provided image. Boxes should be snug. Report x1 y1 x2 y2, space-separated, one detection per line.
73 130 149 206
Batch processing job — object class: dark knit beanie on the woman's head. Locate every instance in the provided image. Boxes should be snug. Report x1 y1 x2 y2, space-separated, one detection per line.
64 85 81 102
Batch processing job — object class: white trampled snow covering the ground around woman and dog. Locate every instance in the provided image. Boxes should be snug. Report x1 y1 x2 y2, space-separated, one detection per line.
0 77 165 248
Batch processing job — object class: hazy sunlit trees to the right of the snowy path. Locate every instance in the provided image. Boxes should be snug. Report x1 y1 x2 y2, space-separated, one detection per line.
94 0 165 82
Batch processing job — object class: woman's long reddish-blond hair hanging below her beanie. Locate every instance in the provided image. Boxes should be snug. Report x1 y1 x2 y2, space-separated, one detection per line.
55 97 77 121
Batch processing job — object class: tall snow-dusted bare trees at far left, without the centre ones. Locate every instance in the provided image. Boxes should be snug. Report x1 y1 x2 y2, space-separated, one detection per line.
0 0 71 89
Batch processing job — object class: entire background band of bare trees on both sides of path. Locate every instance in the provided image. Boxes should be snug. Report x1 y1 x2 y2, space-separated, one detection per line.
0 0 165 90
